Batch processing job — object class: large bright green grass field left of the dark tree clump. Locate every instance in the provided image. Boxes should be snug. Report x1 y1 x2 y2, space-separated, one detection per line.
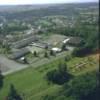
0 58 62 100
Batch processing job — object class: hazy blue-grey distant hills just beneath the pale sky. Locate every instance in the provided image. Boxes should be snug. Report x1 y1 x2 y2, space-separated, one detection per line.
0 3 99 20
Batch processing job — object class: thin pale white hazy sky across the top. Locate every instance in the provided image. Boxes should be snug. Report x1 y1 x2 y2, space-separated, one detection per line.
0 0 99 5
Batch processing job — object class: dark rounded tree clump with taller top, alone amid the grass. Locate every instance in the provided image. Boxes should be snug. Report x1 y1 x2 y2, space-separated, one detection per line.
46 63 71 85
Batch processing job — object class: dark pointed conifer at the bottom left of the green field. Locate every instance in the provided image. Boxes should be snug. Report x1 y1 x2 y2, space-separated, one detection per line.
7 84 22 100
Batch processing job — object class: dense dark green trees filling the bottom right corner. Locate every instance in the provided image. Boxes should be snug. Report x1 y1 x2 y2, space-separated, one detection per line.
64 72 99 100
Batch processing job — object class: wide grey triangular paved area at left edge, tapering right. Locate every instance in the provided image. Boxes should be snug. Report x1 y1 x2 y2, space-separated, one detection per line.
0 55 28 75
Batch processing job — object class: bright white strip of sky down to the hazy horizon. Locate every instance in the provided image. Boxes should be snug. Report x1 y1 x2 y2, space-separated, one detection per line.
0 0 99 6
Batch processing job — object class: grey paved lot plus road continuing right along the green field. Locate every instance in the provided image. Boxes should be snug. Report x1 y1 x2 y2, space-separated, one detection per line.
0 52 69 75
